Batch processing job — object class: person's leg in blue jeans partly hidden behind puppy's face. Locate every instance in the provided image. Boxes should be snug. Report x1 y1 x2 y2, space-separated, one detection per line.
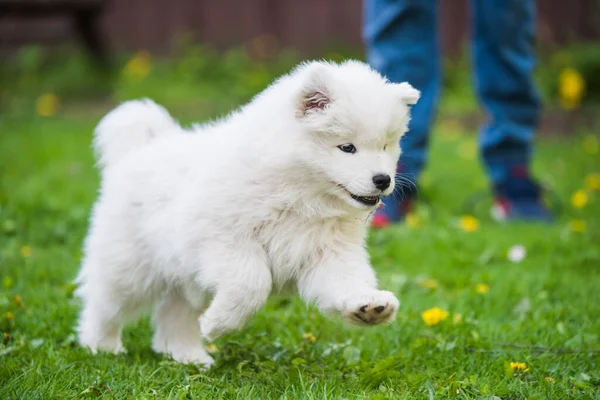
363 0 440 225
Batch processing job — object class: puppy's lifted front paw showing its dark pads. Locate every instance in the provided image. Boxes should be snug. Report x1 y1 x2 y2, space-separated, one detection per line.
343 290 400 326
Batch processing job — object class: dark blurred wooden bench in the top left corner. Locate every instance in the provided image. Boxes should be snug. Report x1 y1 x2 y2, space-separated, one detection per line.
0 0 109 69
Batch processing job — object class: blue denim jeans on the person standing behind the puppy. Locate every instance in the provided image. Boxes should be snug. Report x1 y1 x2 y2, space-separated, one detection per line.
363 0 540 185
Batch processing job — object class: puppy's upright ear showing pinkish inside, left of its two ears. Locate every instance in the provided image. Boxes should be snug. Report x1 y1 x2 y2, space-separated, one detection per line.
297 63 331 117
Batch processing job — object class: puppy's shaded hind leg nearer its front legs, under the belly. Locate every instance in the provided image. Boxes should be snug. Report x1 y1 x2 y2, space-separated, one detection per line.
152 292 214 368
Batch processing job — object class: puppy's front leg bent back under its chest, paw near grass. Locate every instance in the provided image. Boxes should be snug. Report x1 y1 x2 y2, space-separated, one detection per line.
200 243 272 340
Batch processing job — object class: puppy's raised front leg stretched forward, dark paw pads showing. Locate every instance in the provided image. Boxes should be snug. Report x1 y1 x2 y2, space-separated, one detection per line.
298 248 400 326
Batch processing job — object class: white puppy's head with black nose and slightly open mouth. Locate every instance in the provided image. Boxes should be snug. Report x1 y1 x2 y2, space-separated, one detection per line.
296 61 420 209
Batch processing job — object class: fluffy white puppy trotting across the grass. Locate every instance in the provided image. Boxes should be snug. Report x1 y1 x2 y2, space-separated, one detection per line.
77 57 419 366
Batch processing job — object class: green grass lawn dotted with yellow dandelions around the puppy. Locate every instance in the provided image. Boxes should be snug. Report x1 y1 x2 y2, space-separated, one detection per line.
0 104 600 399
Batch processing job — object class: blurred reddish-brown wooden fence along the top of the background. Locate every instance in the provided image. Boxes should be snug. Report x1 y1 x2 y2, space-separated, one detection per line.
0 0 600 54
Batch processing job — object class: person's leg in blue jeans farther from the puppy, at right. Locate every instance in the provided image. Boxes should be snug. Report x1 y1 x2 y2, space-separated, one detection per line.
472 0 548 219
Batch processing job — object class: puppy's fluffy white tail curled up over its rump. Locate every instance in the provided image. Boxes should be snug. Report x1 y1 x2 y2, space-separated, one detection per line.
94 99 180 168
